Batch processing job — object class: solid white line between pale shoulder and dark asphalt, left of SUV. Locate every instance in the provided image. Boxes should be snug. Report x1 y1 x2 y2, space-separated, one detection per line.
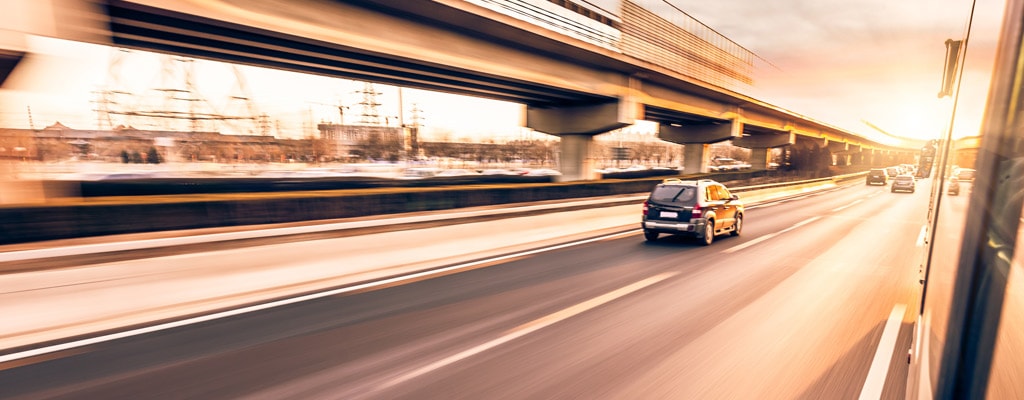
0 229 640 364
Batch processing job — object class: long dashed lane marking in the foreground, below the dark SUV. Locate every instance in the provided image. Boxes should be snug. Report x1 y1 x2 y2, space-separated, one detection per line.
379 272 679 390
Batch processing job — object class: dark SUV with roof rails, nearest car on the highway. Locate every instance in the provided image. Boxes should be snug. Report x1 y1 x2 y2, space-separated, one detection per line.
641 178 743 246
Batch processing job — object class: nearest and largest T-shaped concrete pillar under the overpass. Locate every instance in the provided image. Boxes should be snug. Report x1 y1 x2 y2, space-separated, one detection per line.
524 99 642 181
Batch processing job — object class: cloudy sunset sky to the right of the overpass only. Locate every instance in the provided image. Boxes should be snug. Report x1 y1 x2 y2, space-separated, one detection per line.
673 0 1005 138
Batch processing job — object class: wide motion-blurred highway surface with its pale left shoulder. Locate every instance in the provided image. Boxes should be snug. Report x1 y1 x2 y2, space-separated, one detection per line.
0 180 931 399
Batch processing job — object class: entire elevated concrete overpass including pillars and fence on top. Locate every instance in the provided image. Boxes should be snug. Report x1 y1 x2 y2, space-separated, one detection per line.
0 0 920 180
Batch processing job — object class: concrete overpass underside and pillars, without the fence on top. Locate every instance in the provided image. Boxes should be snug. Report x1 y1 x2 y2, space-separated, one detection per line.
0 0 917 179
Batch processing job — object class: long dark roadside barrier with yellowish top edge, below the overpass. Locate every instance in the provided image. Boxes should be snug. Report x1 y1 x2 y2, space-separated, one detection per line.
0 173 868 245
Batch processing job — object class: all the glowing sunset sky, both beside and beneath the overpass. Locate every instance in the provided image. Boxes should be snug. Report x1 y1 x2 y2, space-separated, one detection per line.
0 0 1004 143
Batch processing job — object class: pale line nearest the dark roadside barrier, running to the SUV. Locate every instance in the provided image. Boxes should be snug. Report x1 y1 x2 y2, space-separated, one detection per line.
0 196 646 262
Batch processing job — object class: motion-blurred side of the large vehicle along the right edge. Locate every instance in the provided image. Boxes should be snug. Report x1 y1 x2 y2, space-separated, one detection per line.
908 2 1024 399
